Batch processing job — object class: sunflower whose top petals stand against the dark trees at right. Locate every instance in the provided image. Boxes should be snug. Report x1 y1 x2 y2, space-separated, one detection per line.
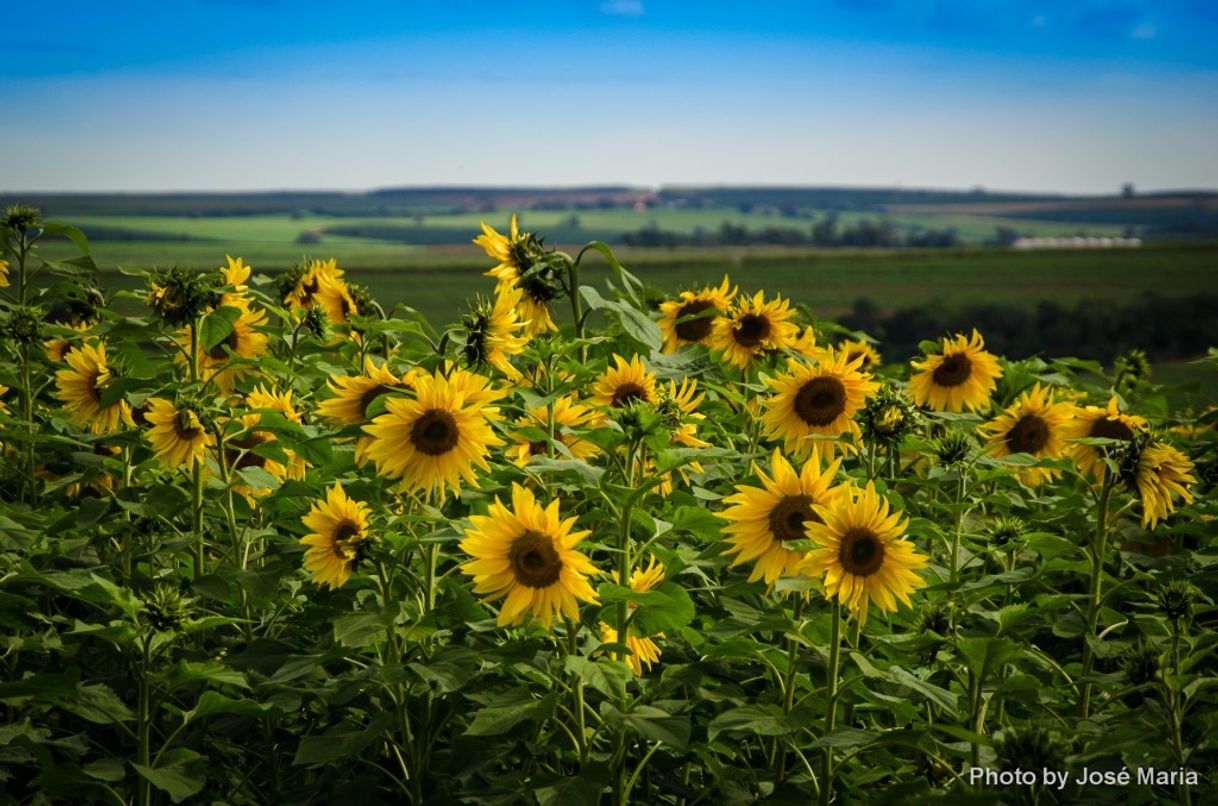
910 328 1002 413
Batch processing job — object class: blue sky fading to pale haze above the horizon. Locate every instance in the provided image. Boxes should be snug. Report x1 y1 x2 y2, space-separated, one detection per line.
0 0 1218 192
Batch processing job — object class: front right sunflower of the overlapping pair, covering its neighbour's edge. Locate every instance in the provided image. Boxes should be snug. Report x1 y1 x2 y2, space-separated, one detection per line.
800 481 927 625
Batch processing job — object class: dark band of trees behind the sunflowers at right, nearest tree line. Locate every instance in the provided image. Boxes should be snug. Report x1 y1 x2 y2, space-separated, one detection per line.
842 295 1218 362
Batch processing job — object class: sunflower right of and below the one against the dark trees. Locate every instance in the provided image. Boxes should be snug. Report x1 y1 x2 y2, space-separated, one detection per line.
980 384 1073 487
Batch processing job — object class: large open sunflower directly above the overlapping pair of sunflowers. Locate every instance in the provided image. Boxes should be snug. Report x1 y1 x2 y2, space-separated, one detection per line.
760 348 879 459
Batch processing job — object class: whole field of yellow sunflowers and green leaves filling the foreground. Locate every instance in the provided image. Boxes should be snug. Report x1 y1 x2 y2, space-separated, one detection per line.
0 207 1218 806
